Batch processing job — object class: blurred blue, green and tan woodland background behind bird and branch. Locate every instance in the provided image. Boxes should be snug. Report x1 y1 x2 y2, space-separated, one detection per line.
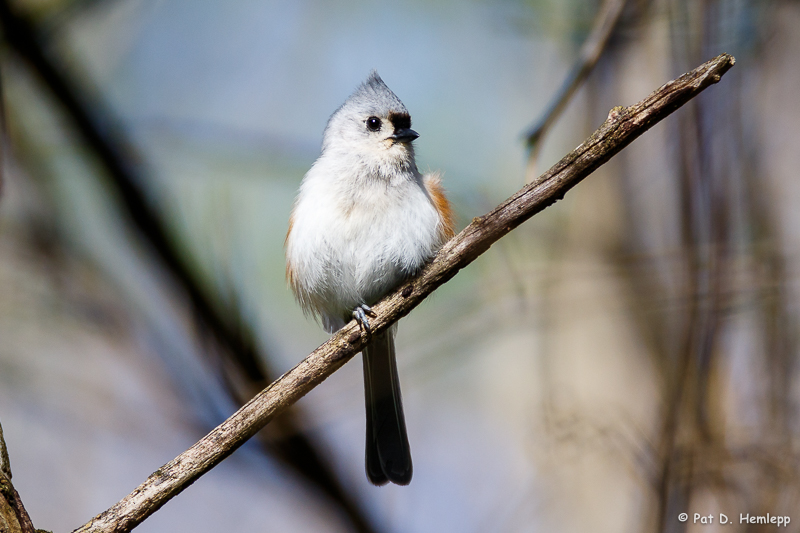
0 0 800 533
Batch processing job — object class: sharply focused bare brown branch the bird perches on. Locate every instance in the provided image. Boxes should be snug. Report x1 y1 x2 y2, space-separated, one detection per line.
76 54 735 533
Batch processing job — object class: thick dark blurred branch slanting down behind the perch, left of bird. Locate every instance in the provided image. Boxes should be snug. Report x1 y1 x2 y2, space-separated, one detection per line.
0 0 374 532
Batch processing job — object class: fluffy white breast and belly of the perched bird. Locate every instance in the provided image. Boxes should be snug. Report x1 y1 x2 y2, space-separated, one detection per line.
286 154 441 331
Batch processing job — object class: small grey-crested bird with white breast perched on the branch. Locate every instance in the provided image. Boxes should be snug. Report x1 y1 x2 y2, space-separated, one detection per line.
285 70 454 486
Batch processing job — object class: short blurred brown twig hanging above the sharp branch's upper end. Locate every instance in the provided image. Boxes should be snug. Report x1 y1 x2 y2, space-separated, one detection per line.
525 0 628 182
